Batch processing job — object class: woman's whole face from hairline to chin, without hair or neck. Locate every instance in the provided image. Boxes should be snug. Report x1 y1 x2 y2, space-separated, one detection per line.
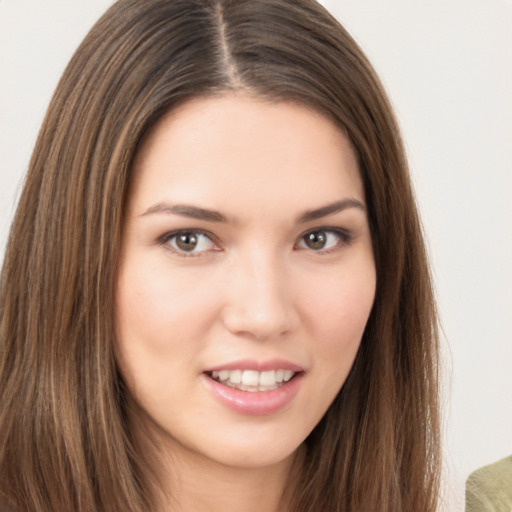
116 95 375 468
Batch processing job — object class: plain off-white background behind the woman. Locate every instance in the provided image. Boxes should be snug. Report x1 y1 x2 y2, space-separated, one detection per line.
0 0 512 512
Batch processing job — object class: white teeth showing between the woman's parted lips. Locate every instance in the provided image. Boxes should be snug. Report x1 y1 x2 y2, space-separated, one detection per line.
206 369 301 393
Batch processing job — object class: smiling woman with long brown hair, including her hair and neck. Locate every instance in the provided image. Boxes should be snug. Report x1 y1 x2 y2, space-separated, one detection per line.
0 0 439 512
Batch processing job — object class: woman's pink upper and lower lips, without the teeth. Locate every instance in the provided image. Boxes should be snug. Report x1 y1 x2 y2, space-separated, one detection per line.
203 360 304 416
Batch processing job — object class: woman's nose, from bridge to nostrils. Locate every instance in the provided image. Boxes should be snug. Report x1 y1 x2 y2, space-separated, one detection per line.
223 251 299 340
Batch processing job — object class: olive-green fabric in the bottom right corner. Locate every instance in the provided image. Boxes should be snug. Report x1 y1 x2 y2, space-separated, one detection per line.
466 456 512 512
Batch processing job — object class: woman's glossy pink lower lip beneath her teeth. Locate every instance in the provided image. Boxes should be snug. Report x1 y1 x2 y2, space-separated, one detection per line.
203 373 303 416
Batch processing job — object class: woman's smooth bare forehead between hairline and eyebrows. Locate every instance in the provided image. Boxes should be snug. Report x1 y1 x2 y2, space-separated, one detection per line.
131 94 364 216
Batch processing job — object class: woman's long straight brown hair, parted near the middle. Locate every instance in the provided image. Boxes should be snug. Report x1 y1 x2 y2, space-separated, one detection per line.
0 0 439 512
